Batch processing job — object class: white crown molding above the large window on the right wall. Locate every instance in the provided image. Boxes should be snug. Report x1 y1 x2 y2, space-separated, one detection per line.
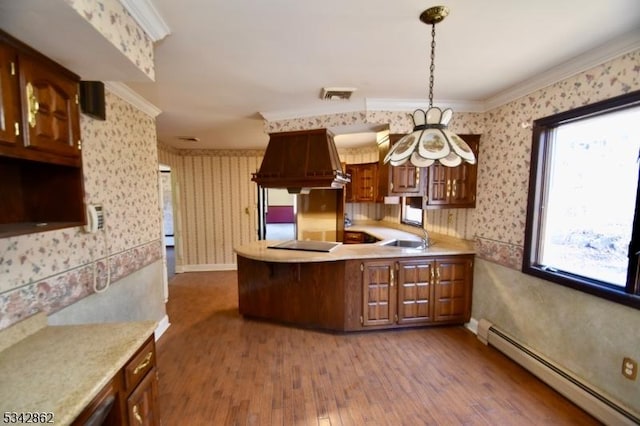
484 30 640 111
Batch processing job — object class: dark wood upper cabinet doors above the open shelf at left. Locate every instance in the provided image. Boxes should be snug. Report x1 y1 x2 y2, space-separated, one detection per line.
0 33 80 167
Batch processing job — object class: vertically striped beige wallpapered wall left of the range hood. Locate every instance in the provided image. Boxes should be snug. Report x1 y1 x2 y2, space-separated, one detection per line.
159 147 263 272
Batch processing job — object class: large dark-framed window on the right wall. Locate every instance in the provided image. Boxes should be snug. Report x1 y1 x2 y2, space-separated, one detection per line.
522 92 640 308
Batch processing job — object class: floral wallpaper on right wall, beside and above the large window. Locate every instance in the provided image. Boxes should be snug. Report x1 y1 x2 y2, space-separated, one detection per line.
474 50 640 269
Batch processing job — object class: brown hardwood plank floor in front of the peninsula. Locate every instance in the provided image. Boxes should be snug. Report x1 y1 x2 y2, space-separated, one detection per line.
157 271 598 426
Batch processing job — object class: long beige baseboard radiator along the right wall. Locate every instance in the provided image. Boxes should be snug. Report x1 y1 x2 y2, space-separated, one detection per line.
478 319 640 426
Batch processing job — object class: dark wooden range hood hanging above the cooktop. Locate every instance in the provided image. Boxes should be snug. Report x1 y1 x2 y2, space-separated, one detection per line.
251 129 350 194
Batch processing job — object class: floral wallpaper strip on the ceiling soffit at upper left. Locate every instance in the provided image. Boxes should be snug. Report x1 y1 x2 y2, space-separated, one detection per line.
65 0 155 80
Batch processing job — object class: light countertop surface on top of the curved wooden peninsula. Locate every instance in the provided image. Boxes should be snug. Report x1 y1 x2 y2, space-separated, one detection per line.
234 225 475 263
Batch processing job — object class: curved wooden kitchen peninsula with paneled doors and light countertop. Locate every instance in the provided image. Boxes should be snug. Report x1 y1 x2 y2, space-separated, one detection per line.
235 226 474 331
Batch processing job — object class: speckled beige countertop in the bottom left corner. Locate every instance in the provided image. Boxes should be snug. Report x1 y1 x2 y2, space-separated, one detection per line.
0 321 156 425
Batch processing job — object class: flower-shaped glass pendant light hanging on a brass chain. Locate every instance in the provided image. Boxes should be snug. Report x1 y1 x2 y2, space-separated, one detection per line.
384 6 476 167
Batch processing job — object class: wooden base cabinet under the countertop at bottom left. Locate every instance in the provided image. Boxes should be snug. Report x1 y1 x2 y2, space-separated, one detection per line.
72 335 160 426
